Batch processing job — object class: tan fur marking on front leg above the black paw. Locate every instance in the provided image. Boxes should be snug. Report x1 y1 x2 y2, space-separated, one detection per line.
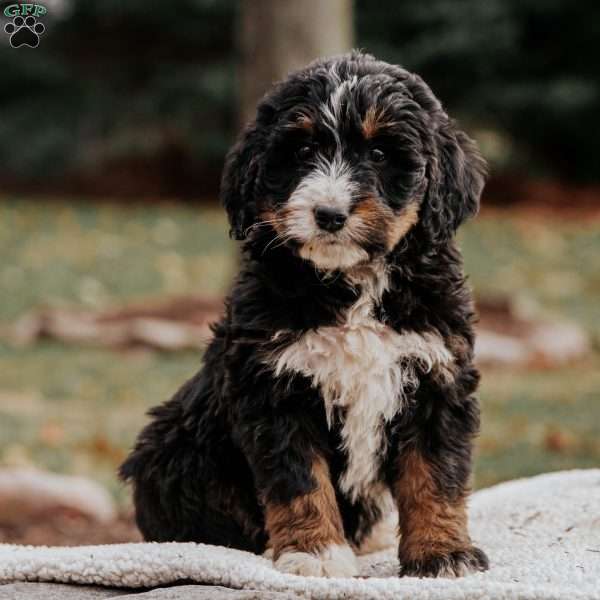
394 451 471 561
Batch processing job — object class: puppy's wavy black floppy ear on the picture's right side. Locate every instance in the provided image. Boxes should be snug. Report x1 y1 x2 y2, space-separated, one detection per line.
421 122 487 243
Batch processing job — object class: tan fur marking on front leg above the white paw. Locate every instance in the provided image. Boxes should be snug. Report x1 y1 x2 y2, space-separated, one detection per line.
265 458 346 560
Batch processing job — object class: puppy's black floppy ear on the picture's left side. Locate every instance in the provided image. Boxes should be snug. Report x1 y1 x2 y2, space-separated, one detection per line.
221 122 263 240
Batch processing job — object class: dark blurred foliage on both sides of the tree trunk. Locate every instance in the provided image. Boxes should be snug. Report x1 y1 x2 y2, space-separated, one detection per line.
0 0 600 196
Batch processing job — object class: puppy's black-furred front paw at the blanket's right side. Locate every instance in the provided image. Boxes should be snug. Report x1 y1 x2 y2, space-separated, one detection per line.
400 546 490 578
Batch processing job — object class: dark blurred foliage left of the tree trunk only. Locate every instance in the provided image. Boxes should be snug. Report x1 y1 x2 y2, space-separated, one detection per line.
0 0 235 195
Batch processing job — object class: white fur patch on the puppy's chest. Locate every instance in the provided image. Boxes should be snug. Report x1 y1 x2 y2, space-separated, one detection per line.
275 264 453 500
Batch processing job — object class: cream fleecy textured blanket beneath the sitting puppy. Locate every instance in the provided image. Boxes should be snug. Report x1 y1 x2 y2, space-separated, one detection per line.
0 469 600 600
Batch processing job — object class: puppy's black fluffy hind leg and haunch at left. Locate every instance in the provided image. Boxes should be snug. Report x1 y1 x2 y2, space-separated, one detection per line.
120 383 266 552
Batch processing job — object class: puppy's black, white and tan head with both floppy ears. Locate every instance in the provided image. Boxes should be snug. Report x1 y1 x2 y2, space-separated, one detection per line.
221 53 485 270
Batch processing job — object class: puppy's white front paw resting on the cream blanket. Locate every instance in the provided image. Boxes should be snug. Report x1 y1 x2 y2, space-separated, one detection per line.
275 544 358 577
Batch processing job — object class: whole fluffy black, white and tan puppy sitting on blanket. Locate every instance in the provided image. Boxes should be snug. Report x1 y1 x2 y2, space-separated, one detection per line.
120 52 488 577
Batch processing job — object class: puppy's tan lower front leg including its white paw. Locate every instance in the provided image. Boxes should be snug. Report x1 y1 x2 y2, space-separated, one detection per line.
265 456 357 577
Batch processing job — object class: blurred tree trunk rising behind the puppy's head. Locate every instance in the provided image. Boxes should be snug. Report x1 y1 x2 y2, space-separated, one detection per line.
239 0 353 124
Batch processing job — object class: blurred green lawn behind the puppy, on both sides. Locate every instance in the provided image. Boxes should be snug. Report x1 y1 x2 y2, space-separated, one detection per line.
0 198 600 498
